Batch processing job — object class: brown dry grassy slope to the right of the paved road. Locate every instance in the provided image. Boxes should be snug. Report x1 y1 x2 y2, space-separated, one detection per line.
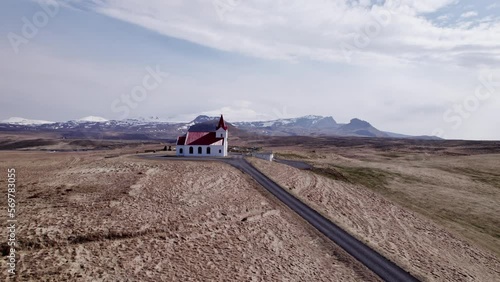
251 147 500 281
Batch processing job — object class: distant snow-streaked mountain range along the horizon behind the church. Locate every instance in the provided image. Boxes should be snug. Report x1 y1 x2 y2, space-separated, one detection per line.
0 115 439 140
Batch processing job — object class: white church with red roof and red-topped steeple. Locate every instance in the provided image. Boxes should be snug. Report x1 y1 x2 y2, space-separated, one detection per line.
176 115 228 157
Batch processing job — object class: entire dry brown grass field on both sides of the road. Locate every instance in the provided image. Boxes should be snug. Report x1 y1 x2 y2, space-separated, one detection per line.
0 133 500 281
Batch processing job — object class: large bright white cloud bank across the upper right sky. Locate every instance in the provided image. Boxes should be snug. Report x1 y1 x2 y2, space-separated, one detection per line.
53 0 500 68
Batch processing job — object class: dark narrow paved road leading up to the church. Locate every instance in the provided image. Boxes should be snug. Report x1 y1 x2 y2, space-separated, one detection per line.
139 156 419 281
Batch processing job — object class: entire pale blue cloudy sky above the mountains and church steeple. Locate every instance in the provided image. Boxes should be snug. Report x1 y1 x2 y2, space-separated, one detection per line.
0 0 500 140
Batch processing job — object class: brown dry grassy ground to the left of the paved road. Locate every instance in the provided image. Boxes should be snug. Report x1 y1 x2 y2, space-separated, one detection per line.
0 152 376 281
